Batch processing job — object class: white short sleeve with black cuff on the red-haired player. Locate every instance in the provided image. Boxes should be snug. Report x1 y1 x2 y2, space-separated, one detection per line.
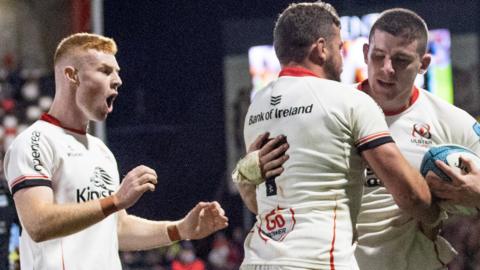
4 129 53 195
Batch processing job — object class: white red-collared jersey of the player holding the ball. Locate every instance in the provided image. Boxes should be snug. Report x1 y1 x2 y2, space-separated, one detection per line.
355 81 480 270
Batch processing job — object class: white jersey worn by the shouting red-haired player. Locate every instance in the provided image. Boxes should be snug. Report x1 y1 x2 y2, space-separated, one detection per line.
5 114 121 270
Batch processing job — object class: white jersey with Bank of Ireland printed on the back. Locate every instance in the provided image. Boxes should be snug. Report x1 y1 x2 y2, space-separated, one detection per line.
242 68 392 270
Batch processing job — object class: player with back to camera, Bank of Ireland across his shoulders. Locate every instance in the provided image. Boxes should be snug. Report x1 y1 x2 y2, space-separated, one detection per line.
235 2 437 269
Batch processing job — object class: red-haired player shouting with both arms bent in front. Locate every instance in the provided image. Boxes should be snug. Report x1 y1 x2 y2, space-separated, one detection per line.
5 33 228 270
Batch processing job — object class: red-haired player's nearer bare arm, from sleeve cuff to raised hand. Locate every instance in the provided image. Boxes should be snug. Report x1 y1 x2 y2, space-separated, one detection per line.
14 165 157 242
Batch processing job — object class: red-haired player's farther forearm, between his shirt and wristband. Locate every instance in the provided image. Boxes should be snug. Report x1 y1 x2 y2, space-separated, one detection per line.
118 211 180 251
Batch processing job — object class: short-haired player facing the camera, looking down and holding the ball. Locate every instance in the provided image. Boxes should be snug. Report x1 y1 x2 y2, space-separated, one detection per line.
235 8 480 270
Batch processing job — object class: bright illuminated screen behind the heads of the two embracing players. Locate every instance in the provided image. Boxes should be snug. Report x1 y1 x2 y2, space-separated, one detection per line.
248 13 453 104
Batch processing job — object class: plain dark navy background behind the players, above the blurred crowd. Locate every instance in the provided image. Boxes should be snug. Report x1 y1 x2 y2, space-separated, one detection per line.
104 0 480 228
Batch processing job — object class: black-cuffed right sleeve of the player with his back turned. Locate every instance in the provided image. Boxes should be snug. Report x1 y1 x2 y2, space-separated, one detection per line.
351 92 393 153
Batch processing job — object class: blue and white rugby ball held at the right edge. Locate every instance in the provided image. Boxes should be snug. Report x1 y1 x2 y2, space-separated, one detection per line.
420 144 480 182
